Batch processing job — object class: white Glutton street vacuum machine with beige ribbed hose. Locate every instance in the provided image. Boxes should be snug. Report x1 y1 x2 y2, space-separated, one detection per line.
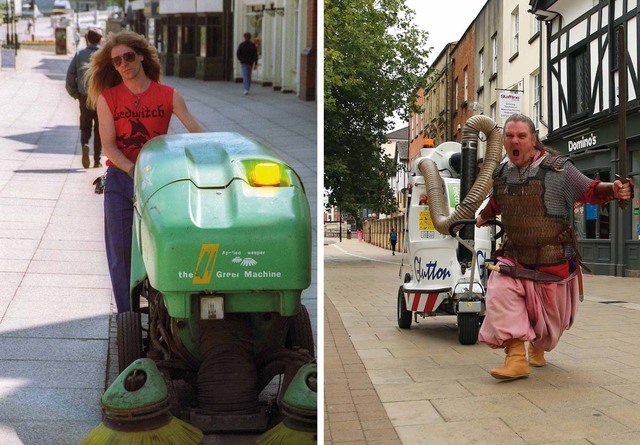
397 115 502 345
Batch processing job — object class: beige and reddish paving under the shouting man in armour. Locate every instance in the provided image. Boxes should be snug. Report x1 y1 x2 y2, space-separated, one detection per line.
324 239 640 445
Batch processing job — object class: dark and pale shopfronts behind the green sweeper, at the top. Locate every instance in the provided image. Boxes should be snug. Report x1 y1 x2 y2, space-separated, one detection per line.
126 0 317 100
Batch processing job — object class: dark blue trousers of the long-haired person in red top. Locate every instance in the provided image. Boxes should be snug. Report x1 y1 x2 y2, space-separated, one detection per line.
104 166 133 314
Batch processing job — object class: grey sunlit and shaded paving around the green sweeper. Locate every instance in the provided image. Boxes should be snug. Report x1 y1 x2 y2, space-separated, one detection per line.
0 46 317 445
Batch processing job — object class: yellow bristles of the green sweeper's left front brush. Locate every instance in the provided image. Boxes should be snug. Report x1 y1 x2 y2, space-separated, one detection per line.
82 417 204 445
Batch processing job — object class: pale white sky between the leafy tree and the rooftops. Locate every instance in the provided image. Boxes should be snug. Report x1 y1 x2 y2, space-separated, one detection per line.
394 0 487 130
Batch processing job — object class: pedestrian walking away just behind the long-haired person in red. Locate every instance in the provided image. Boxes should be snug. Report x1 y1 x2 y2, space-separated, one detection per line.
65 28 102 168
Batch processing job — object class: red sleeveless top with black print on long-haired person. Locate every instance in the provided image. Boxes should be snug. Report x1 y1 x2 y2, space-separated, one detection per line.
102 81 173 165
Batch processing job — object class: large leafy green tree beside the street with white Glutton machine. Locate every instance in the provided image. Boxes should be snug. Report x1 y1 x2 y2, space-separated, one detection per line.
324 0 429 222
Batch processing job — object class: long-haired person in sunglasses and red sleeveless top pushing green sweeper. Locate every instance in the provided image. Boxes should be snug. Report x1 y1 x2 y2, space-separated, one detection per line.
87 31 204 313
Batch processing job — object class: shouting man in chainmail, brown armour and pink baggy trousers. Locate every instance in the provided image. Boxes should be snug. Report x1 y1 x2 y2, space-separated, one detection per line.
476 114 633 379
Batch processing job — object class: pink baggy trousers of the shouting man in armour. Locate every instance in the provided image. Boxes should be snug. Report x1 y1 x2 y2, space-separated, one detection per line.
479 273 579 351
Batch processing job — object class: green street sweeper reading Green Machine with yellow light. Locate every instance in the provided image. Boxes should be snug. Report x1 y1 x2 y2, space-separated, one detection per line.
117 133 314 432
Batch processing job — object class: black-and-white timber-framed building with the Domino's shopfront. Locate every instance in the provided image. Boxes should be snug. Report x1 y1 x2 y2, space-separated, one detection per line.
531 0 640 276
